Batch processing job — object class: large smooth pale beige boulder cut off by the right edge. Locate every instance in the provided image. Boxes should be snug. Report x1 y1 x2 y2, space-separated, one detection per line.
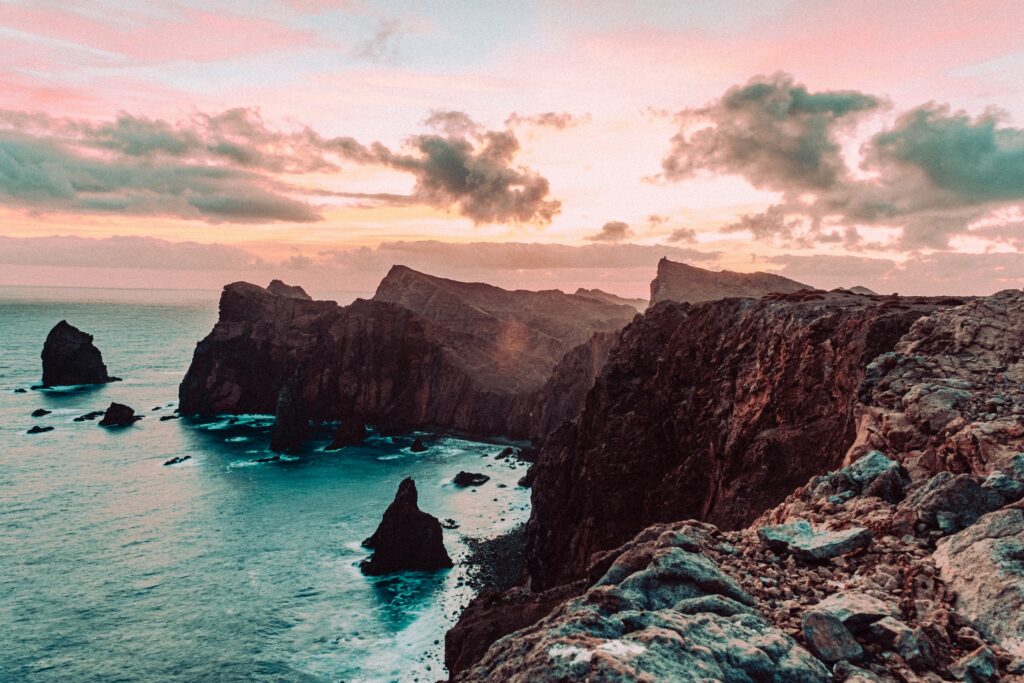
934 507 1024 656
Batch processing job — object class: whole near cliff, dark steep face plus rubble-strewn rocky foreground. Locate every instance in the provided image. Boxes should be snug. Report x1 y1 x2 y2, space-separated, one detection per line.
449 291 1024 683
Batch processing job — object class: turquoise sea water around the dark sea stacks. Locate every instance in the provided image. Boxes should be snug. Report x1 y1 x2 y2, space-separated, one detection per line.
0 288 528 682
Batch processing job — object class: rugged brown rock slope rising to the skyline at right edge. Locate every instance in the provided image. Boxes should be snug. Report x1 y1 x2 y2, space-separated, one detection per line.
847 290 1024 475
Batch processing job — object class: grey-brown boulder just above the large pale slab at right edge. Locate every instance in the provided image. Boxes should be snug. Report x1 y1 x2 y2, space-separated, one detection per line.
904 472 1002 533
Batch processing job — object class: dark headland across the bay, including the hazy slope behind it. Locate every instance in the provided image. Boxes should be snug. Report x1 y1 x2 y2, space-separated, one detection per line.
179 269 633 437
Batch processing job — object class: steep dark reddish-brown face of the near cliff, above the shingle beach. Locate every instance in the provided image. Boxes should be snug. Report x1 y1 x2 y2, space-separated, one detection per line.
527 293 950 589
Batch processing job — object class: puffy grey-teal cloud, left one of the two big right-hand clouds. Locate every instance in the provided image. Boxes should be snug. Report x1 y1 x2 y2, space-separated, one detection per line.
662 74 882 190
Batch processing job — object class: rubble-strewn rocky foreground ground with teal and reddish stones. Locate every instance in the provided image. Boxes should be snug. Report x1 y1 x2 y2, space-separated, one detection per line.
449 291 1024 683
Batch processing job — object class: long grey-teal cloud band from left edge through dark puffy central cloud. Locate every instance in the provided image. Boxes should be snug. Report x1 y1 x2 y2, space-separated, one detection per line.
0 109 560 223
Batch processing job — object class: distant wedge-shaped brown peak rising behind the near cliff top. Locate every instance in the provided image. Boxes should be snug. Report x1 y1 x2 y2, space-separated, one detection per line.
650 258 814 306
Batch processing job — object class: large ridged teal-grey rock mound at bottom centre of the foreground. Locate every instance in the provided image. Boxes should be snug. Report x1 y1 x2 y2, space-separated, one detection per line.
454 526 830 683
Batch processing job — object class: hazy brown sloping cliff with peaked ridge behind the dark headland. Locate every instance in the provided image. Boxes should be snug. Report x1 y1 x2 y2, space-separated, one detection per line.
374 265 636 392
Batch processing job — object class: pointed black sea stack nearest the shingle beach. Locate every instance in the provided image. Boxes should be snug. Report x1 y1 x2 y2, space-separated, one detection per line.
360 477 452 577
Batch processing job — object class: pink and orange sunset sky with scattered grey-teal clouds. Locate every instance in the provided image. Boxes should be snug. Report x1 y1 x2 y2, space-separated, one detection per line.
0 0 1024 297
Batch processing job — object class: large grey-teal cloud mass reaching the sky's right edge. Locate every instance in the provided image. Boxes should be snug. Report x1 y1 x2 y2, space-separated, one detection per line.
664 75 1024 250
